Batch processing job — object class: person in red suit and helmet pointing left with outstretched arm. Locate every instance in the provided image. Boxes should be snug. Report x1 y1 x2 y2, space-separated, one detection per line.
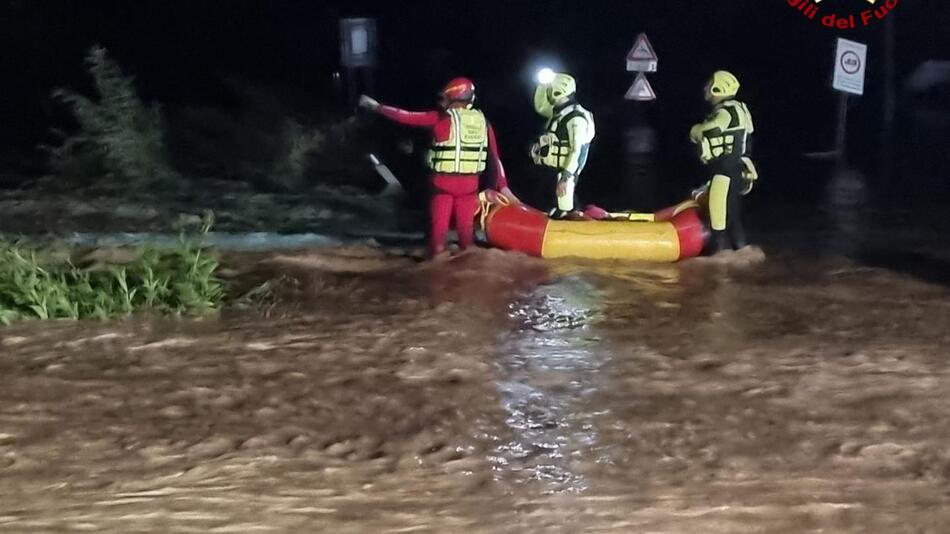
360 78 518 258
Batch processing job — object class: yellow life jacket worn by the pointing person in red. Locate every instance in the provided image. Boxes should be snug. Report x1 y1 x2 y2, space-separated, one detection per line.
427 108 488 174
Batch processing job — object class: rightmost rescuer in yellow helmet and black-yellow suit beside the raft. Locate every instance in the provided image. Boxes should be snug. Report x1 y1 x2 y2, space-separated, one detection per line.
689 70 758 253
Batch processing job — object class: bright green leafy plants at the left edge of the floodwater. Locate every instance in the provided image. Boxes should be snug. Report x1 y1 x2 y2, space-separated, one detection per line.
0 221 225 324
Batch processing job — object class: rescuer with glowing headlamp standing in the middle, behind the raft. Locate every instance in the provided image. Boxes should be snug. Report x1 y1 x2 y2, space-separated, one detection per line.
531 73 595 219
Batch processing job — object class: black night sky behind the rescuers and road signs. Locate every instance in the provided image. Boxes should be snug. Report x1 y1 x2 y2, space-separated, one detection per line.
0 0 950 200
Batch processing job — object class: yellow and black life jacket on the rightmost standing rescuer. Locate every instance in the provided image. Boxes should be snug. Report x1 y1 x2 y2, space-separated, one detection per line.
691 100 755 163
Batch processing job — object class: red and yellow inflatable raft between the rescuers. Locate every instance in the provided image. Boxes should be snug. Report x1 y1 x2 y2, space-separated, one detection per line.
480 196 709 263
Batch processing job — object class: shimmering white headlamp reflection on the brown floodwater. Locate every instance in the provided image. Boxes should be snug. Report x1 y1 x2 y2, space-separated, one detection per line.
491 276 610 492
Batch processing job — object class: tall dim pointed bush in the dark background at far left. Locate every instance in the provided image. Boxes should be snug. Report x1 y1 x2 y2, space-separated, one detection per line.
43 46 178 186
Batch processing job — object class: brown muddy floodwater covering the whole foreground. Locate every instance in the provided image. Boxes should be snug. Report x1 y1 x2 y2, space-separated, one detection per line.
0 248 950 533
